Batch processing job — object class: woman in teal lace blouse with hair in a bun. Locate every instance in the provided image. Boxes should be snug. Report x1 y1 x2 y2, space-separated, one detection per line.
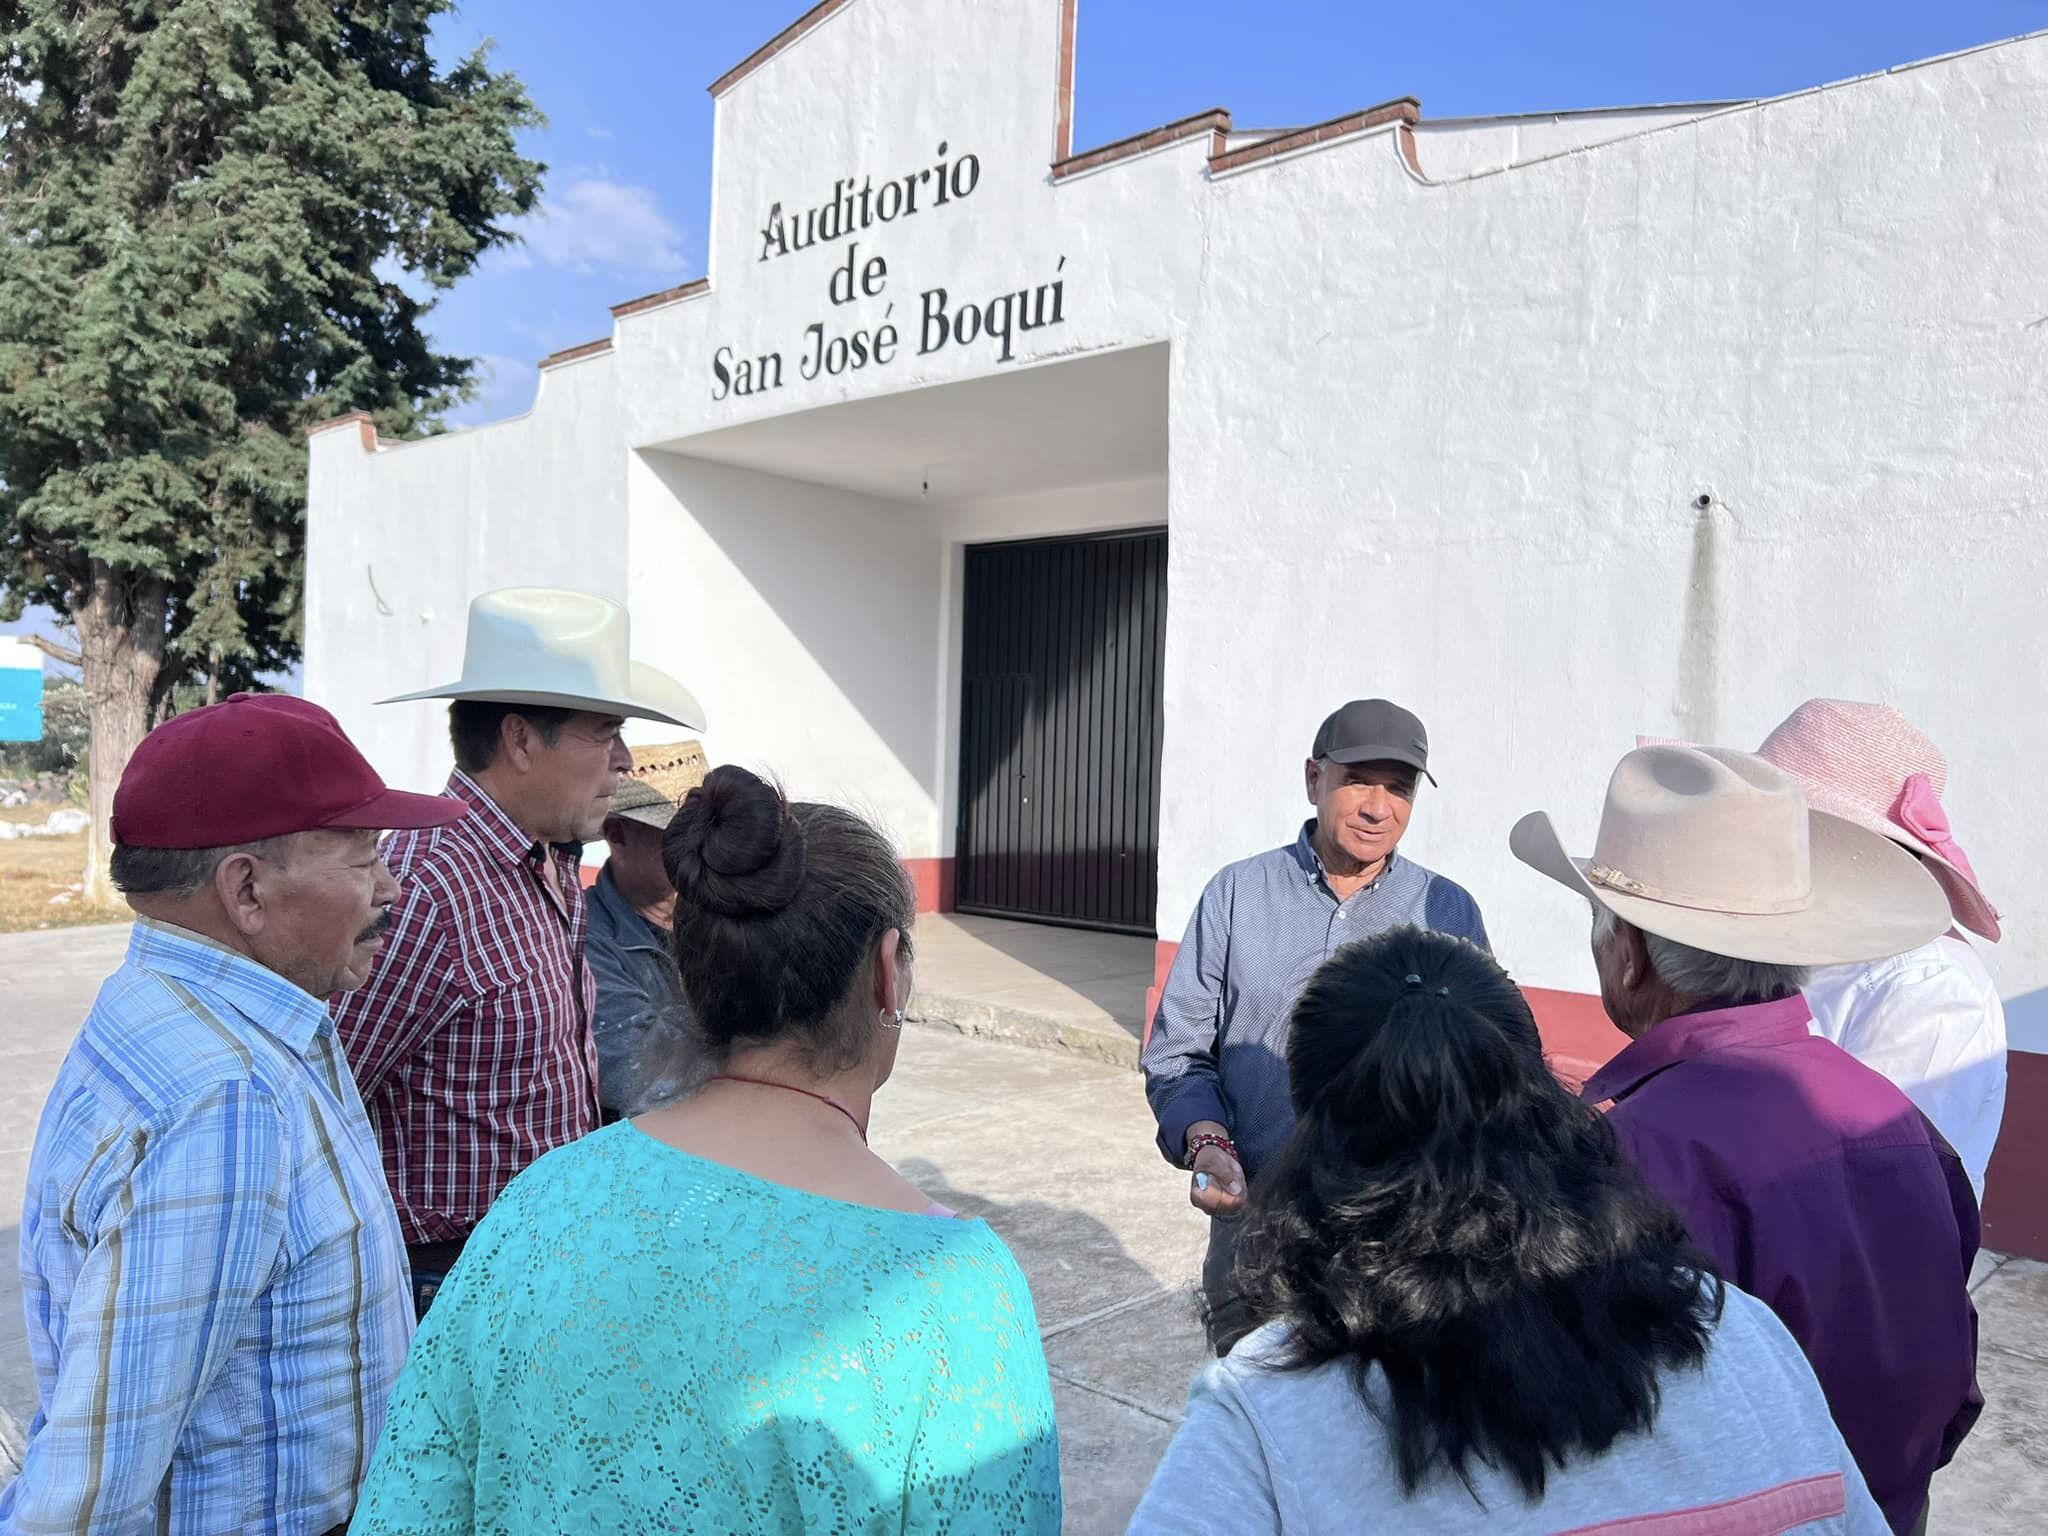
352 768 1061 1536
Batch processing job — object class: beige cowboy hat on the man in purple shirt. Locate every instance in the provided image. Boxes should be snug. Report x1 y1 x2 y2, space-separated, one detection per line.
1507 745 1950 965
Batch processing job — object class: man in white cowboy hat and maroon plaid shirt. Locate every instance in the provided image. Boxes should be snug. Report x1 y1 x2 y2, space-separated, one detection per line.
334 588 705 1315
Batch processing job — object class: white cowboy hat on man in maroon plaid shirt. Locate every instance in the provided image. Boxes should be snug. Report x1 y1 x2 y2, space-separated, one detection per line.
377 586 705 731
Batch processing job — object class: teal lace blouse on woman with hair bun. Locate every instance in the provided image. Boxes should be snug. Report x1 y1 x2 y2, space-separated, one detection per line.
352 1122 1061 1536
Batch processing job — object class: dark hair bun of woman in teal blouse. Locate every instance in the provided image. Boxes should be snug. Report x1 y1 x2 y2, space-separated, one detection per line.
662 764 805 918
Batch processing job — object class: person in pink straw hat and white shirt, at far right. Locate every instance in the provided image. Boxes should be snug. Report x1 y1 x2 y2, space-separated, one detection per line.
1646 698 2005 1200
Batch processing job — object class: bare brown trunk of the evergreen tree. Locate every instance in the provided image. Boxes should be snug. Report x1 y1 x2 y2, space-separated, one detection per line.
72 561 170 905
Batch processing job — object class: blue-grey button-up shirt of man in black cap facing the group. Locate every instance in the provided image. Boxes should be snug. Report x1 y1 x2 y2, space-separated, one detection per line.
1145 819 1487 1174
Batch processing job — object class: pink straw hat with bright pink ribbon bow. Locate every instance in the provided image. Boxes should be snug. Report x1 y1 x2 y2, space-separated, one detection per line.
1636 698 1999 942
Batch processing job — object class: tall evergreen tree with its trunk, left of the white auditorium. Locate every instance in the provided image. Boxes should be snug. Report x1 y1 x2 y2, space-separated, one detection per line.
0 0 543 895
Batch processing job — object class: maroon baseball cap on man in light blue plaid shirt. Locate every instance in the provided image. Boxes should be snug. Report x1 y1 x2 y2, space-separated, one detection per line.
113 694 469 848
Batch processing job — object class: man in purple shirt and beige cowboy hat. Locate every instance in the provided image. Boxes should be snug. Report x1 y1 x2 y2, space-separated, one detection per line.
1509 745 1982 1534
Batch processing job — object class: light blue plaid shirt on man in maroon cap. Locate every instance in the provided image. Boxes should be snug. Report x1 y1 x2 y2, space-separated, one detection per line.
0 922 412 1536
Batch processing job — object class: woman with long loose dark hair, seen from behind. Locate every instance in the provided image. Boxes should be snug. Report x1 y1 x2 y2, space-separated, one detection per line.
1130 928 1886 1536
